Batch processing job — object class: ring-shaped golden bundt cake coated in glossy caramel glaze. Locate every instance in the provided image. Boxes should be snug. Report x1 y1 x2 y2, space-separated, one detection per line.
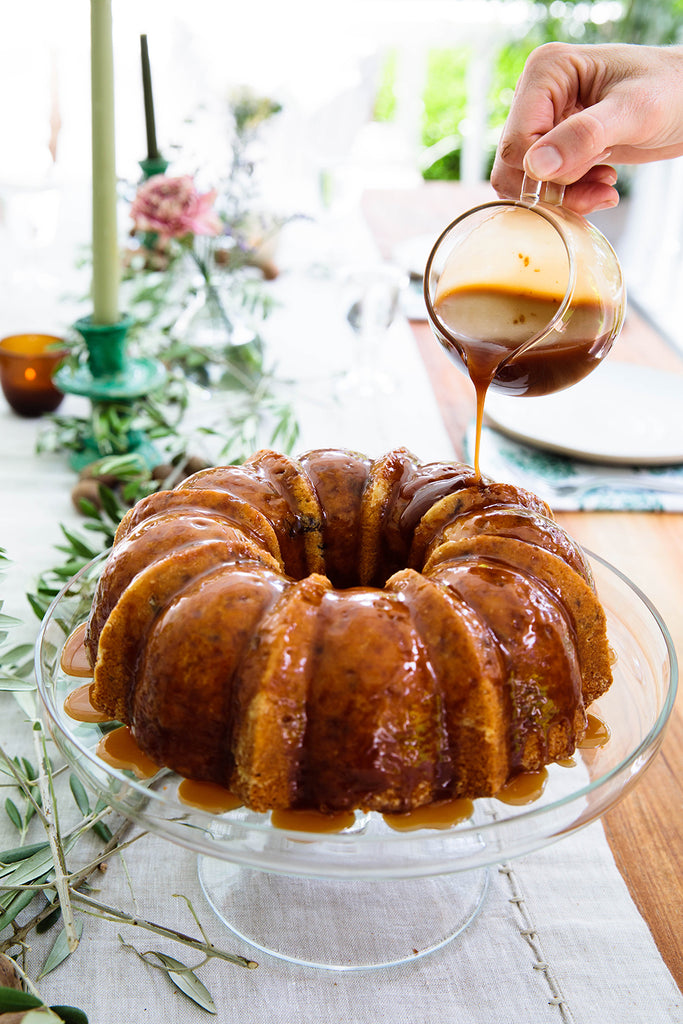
86 449 611 812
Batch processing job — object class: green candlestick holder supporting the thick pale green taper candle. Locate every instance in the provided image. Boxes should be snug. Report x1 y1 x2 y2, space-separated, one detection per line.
54 316 166 470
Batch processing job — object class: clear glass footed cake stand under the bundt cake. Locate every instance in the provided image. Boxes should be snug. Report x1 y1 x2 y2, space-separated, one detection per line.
36 556 677 971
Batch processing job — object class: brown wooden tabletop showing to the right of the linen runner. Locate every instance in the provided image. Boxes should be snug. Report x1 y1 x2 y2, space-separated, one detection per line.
364 182 683 988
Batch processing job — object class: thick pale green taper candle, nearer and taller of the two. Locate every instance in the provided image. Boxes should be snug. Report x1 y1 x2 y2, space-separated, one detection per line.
90 0 121 324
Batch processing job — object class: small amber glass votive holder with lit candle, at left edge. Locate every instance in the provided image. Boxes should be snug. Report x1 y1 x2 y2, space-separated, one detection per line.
0 334 67 417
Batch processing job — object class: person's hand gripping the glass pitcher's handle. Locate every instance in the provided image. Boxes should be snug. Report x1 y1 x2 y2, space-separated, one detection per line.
490 43 683 214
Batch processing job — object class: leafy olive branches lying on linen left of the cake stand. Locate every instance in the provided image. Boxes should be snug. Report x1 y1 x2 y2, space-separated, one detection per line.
0 544 257 1024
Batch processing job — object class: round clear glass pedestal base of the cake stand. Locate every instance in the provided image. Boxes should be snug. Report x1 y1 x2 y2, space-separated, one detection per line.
199 856 488 971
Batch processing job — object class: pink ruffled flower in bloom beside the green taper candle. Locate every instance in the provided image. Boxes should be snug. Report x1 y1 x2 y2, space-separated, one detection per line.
130 174 222 240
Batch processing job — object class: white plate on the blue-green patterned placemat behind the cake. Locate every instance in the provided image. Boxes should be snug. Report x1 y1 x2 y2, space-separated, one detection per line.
485 360 683 466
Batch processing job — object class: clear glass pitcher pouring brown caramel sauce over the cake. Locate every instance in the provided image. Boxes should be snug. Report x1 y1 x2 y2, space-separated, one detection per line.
424 177 626 400
